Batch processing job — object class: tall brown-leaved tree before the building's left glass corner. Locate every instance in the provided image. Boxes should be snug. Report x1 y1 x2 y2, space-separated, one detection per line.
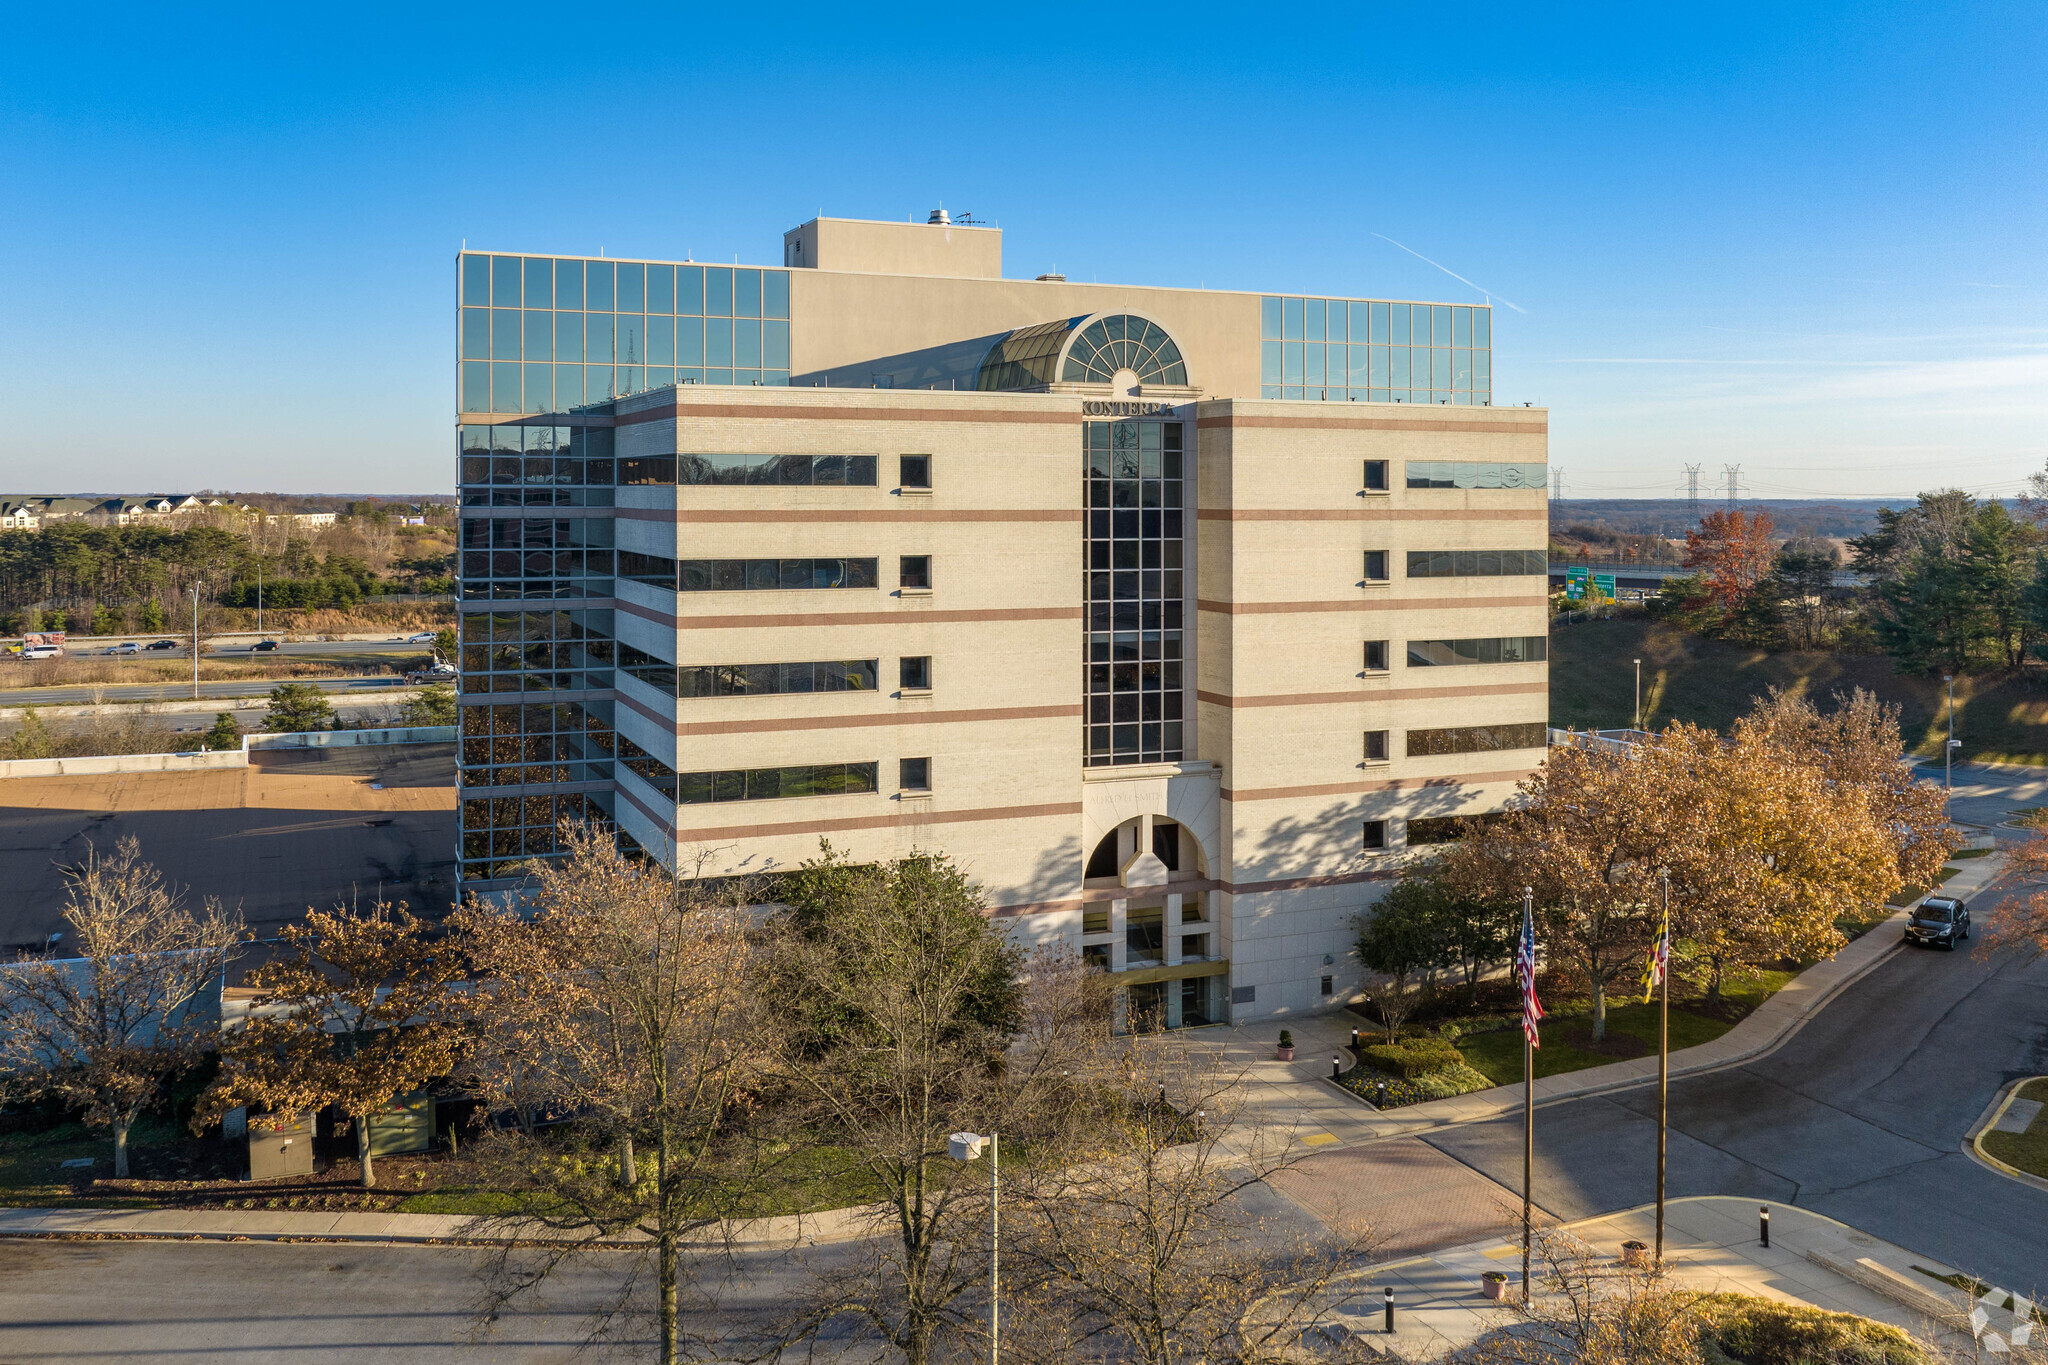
457 825 760 1363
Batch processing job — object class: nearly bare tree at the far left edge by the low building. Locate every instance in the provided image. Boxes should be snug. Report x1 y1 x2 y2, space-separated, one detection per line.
0 837 242 1179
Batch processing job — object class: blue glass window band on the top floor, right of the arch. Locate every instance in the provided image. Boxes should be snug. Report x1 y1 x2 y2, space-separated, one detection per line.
1260 295 1493 407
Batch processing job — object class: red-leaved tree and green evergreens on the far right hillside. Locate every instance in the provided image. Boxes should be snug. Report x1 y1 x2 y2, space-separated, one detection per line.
1653 485 2048 673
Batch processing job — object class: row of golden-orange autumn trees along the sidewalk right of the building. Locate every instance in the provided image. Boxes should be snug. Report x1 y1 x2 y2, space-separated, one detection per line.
1358 690 1960 1040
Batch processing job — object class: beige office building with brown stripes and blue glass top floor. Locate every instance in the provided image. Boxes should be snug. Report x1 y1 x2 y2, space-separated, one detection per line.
457 215 1548 1027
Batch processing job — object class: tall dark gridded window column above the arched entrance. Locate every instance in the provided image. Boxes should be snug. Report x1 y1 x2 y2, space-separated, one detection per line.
1081 422 1188 765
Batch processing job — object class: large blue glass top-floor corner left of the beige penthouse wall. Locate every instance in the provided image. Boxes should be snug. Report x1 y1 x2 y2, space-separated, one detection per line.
457 252 788 413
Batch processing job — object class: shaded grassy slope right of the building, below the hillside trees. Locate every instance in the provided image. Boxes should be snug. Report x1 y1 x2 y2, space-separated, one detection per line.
1550 612 2048 763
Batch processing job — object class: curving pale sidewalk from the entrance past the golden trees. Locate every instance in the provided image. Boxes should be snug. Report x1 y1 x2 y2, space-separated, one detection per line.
1204 853 2005 1146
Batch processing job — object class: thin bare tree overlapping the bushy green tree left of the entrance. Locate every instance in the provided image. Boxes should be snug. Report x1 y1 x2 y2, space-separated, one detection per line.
766 847 1081 1365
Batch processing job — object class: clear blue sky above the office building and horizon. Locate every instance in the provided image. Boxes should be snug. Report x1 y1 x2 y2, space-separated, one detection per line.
0 4 2048 497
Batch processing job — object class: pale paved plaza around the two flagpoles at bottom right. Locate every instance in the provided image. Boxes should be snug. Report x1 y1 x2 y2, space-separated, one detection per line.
1310 1195 2013 1361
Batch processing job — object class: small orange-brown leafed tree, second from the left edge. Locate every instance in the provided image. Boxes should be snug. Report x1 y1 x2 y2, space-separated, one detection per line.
193 900 463 1187
